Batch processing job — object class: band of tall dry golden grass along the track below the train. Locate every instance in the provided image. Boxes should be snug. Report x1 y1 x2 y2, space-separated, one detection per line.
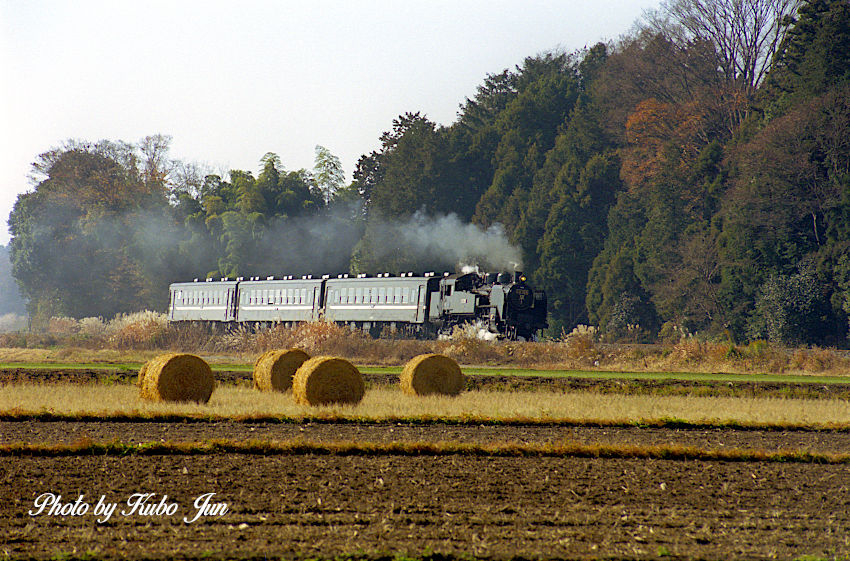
0 312 850 375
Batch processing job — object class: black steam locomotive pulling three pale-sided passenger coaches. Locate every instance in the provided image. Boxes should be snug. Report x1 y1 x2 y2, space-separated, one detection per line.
168 271 548 340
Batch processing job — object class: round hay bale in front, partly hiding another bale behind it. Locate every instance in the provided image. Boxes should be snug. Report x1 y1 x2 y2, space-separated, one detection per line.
292 356 366 405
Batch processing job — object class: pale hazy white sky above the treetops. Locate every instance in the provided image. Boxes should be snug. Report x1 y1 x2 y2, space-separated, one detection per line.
0 0 658 244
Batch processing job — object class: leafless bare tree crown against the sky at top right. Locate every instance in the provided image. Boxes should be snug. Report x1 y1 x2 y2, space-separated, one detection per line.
646 0 802 98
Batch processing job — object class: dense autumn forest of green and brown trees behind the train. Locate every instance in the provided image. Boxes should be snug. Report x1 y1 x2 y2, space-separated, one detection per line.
9 0 850 347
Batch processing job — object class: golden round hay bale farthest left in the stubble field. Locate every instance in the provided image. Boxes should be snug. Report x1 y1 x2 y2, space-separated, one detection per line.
139 353 215 403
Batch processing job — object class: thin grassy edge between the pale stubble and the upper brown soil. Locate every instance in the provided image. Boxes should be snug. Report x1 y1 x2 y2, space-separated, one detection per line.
0 410 850 432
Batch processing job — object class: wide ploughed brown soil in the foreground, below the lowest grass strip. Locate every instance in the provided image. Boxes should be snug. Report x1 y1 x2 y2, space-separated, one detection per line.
0 454 850 559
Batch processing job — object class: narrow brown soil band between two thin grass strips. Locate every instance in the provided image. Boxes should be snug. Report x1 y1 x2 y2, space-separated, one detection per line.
0 420 850 454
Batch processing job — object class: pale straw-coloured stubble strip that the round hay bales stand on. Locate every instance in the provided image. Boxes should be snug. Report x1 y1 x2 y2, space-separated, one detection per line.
0 384 850 426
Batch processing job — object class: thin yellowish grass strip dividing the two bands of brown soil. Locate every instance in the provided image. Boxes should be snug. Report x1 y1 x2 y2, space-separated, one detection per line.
0 440 850 464
